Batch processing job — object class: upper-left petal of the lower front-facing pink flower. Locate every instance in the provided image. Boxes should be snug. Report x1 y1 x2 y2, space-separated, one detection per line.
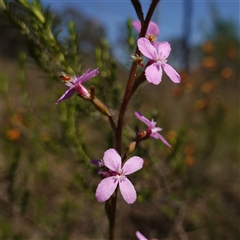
103 148 122 172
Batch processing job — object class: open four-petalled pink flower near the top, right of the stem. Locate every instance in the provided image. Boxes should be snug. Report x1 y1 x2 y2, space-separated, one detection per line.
137 38 181 85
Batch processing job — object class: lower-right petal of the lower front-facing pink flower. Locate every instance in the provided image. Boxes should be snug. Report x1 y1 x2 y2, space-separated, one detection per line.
119 177 137 204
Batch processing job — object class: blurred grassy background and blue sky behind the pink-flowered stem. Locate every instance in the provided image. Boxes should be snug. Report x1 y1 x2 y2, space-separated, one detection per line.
0 0 240 240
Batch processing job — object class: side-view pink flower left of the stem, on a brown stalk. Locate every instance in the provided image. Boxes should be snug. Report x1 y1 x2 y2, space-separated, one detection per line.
56 69 98 104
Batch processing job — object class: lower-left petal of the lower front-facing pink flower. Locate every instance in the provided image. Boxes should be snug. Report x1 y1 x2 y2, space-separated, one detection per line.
96 177 118 202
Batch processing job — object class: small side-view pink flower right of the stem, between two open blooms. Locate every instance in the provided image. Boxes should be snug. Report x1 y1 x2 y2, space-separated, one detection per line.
135 112 171 147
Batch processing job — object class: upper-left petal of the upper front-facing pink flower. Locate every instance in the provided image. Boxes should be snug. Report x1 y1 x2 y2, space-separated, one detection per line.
137 38 157 60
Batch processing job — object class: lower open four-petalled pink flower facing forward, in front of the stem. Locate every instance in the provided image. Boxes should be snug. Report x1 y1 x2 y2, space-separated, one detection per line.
96 148 143 204
